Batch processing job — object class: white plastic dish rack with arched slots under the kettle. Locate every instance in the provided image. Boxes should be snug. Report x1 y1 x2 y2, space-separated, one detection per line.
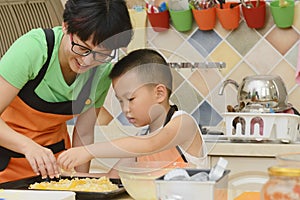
224 112 300 143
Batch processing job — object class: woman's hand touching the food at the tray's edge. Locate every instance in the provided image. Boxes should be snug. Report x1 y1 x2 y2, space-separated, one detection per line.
24 143 59 178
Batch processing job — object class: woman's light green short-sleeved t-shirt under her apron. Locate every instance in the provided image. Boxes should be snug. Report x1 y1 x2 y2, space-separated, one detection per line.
0 26 112 111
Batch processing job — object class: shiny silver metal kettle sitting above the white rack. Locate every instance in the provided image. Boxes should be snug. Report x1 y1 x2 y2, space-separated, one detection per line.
219 75 292 113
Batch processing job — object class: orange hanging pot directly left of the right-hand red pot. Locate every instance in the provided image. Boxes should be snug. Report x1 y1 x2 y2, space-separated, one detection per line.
216 2 241 30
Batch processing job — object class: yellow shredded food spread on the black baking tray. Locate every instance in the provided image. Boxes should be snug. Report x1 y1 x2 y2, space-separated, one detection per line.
29 176 118 192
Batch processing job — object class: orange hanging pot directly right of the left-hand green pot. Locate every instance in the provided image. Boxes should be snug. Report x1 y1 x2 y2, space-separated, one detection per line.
192 7 216 31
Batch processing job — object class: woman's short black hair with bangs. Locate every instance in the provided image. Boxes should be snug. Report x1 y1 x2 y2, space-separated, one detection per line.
63 0 133 49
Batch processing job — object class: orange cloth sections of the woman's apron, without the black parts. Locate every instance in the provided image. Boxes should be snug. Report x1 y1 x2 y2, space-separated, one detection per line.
0 97 73 182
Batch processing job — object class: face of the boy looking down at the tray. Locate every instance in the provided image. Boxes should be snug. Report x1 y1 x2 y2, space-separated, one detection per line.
112 72 162 127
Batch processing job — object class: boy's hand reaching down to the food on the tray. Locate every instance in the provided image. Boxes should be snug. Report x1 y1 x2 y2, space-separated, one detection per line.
57 146 93 171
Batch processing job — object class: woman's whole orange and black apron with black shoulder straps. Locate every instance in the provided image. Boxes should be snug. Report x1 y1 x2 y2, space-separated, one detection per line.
0 29 96 183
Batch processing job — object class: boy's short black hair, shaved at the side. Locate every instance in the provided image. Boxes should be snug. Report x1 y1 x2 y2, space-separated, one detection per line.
109 49 172 96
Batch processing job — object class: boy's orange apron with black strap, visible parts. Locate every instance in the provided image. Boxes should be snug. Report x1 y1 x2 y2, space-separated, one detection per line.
137 105 187 166
